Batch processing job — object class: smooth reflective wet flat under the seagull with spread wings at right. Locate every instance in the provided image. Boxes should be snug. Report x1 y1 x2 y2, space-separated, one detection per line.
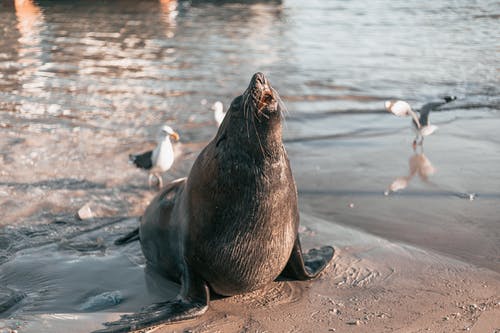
289 104 500 272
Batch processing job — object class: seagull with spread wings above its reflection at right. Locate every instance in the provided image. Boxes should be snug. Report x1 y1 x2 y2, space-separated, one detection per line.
385 96 457 145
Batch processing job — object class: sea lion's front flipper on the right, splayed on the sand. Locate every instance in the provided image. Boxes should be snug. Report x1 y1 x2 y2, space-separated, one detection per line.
281 236 335 280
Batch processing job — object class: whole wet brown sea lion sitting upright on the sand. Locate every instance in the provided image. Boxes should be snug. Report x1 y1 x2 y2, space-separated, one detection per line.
98 73 334 332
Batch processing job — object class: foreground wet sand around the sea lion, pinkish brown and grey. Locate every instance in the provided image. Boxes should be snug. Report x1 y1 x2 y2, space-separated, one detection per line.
0 214 500 333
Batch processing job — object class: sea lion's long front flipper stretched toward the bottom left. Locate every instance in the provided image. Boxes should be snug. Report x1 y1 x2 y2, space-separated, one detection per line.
93 284 209 333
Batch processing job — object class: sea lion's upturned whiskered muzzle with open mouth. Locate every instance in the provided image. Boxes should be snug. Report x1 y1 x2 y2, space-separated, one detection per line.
244 73 279 118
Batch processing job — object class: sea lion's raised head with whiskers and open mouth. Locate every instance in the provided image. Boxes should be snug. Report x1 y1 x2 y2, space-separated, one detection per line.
216 73 284 153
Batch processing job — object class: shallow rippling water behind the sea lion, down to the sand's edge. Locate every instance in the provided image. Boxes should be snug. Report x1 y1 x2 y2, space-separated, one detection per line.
0 0 500 326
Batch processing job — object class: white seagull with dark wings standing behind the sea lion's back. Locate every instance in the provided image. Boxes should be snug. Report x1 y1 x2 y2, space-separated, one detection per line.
128 125 179 188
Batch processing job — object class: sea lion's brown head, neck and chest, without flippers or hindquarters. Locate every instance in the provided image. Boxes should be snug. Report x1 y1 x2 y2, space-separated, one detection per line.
185 73 299 295
